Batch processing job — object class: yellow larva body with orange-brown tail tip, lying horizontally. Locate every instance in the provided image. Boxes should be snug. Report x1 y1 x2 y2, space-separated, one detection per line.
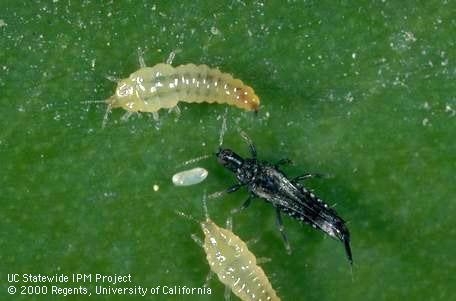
106 63 260 112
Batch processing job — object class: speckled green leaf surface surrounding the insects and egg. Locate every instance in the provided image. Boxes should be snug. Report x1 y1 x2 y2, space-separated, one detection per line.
0 0 456 300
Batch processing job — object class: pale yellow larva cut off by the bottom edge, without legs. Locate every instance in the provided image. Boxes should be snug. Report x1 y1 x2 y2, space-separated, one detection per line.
201 218 280 301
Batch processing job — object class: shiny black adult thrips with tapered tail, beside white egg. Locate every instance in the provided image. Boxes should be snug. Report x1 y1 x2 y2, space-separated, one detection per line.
216 137 353 263
